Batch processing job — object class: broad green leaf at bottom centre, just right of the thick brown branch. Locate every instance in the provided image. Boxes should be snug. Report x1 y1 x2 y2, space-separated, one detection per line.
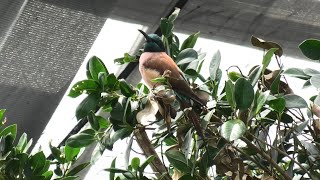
165 150 193 173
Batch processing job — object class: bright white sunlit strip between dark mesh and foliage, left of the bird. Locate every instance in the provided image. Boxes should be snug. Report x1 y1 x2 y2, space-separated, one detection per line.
34 19 142 155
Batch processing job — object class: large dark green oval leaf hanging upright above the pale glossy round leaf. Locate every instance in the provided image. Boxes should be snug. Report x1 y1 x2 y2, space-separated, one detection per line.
234 78 254 110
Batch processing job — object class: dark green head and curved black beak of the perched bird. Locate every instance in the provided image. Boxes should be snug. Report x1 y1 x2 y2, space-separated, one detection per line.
139 30 165 52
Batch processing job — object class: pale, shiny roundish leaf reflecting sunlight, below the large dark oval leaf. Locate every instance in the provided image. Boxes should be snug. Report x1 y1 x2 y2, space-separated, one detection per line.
220 119 246 141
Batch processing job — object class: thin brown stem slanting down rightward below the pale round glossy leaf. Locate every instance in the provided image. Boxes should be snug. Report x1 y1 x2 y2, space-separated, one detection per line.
240 137 291 180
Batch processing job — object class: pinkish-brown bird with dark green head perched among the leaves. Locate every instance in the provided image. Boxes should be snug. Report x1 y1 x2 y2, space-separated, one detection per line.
139 30 207 138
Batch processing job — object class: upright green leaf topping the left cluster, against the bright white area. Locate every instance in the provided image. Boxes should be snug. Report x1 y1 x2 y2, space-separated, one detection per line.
88 56 109 81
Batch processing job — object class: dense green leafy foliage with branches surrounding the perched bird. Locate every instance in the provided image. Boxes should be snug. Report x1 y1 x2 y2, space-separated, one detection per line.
0 9 320 179
